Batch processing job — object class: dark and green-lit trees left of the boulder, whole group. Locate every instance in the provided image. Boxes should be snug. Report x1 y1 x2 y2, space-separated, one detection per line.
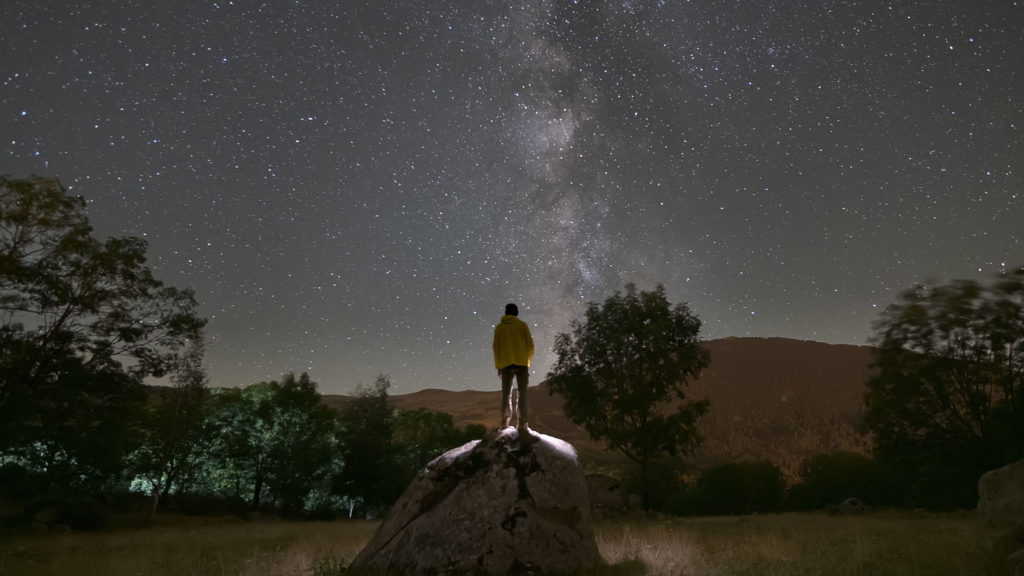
0 175 483 528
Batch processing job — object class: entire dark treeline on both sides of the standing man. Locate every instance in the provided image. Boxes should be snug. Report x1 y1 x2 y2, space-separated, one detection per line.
0 176 1024 527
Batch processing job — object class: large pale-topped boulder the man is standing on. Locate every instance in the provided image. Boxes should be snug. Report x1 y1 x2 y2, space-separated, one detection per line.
351 428 602 576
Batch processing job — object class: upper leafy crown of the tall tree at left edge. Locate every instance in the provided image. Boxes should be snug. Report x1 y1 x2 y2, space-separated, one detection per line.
0 176 206 381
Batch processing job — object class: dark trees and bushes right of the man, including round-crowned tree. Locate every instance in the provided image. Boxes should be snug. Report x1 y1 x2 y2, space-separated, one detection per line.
565 274 1024 513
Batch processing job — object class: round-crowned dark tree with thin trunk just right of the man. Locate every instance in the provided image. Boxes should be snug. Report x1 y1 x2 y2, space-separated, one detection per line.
548 284 709 506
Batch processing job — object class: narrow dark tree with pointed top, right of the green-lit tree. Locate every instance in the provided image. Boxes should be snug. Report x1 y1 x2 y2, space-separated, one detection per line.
334 375 408 513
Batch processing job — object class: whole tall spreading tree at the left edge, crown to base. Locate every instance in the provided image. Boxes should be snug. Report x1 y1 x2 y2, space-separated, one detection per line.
0 176 205 488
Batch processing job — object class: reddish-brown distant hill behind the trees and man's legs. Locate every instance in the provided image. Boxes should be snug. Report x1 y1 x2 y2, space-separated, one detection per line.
324 338 872 478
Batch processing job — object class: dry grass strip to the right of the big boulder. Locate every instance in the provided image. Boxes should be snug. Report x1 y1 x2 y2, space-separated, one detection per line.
598 512 997 576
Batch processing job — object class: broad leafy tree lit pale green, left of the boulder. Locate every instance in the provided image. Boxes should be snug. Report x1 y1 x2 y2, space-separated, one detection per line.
201 373 336 513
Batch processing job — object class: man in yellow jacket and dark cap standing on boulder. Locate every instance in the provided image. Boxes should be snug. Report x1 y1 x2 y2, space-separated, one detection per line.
494 304 534 430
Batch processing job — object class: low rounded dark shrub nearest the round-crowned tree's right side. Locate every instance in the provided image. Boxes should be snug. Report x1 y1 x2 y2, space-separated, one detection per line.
696 460 785 515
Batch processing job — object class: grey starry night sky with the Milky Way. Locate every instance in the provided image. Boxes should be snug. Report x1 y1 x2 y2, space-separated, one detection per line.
0 0 1024 394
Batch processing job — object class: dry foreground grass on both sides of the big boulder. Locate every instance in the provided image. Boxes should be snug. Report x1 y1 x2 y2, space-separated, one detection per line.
0 512 997 576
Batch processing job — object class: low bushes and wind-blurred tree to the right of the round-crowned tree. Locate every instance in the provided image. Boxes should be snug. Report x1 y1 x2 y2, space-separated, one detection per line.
634 268 1024 513
